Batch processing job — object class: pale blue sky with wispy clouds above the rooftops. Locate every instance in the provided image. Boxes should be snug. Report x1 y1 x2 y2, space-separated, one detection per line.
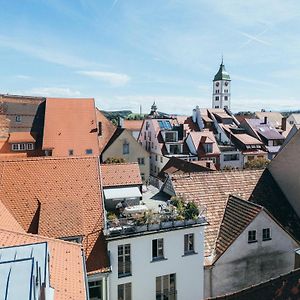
0 0 300 114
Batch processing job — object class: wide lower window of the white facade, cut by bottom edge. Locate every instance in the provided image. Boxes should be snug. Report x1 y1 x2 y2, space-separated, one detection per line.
156 274 177 300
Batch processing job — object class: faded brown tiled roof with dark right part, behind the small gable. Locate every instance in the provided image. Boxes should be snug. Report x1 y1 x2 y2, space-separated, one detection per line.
172 170 300 256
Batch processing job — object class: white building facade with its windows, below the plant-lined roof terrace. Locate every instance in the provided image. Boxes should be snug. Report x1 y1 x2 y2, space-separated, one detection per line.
107 223 205 300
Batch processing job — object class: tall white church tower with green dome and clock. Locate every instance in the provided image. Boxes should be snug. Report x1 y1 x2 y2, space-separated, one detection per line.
212 58 231 109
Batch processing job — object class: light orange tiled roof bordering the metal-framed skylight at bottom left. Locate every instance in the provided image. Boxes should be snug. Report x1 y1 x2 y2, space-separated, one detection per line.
0 229 87 300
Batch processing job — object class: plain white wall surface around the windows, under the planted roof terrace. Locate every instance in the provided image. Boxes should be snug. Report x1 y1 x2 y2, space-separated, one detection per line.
108 226 204 300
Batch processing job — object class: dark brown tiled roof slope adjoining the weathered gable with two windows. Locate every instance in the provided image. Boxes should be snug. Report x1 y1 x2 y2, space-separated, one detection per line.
215 195 263 257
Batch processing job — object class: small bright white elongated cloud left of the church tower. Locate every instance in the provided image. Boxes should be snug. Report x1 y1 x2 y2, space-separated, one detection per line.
77 71 131 86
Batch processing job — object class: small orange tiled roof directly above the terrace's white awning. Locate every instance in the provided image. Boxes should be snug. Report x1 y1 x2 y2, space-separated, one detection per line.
101 163 142 187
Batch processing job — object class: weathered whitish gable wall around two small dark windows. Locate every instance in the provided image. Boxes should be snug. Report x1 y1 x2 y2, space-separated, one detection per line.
205 211 298 297
